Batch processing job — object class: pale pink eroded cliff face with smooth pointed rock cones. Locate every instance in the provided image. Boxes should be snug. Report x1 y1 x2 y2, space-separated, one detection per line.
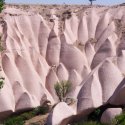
0 6 125 125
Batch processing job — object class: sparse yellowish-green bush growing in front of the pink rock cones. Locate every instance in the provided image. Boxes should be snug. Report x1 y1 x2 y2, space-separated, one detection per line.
54 81 71 101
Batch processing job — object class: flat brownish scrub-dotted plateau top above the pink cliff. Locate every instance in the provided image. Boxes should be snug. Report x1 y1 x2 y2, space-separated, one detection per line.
5 3 125 20
